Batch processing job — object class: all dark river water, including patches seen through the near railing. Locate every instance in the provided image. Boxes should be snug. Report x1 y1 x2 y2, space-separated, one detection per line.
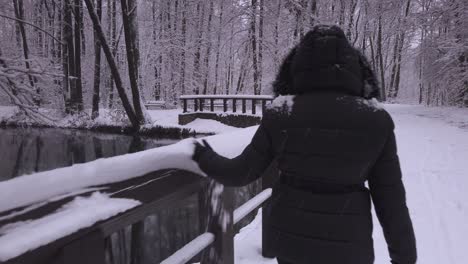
0 128 260 264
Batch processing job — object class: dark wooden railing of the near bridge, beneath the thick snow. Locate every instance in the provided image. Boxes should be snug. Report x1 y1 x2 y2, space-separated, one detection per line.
0 166 277 264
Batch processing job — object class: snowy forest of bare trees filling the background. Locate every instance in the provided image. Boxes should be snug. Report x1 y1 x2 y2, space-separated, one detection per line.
0 0 468 127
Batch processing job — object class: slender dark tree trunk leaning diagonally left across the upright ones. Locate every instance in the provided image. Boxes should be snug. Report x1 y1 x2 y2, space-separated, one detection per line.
84 0 140 129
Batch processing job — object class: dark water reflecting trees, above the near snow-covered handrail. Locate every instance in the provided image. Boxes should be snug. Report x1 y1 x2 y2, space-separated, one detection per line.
0 128 178 181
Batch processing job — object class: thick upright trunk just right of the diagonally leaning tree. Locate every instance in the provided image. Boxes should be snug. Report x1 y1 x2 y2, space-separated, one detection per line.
120 0 145 124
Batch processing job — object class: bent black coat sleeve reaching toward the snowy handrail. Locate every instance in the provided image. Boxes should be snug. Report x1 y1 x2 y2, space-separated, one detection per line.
198 124 274 186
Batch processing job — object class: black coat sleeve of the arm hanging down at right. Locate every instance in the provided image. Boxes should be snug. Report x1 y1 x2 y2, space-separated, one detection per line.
369 124 417 264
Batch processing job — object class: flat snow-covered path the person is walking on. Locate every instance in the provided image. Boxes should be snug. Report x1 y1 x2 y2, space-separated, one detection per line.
236 105 468 264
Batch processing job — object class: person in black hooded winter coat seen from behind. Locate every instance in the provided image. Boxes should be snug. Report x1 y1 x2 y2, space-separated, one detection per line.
194 26 416 264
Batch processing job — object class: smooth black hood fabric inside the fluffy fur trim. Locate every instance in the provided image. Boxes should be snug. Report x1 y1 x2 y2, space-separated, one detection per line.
291 26 363 95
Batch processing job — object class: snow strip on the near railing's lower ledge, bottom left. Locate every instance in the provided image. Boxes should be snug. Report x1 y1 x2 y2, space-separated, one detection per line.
0 192 140 261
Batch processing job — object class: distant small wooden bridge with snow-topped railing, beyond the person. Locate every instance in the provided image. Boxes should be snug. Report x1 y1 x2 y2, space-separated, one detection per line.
179 95 274 127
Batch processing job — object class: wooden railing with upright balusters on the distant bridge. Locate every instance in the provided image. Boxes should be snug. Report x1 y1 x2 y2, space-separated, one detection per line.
179 95 274 115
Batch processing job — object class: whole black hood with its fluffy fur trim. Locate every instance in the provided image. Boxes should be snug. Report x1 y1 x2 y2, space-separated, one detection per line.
273 25 379 98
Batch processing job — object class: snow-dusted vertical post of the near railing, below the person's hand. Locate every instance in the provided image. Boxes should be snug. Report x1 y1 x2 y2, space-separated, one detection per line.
201 181 234 264
